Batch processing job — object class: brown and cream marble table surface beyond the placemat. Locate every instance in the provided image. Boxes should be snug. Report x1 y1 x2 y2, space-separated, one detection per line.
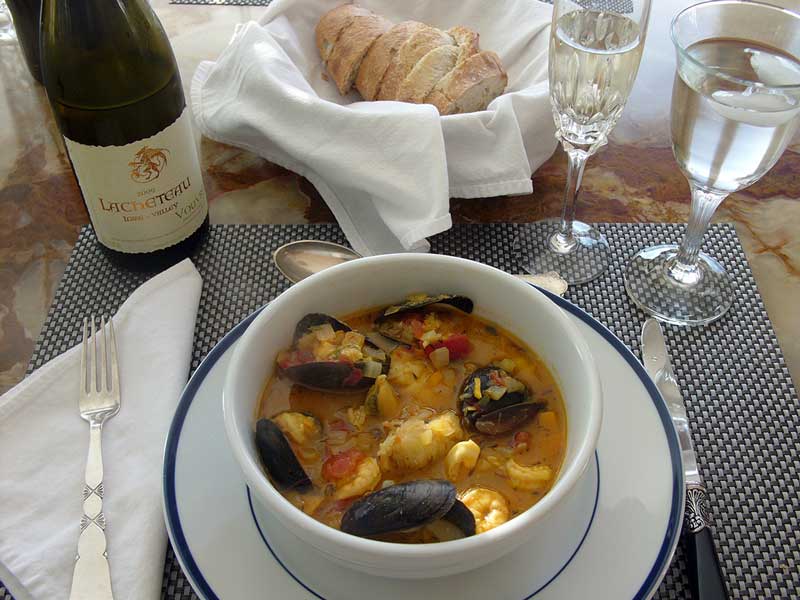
0 0 800 392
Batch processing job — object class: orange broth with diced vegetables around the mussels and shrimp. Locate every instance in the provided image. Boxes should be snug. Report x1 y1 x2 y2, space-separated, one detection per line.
256 305 566 543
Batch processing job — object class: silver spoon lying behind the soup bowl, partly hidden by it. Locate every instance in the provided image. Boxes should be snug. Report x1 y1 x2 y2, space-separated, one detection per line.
272 240 567 296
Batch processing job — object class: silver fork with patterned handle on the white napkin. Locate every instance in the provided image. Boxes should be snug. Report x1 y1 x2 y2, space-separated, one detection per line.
69 315 120 600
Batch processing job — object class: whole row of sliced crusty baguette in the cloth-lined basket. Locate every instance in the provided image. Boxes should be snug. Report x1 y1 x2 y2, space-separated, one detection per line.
316 4 508 115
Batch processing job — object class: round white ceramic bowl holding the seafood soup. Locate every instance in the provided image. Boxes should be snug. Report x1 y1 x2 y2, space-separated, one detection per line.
223 254 602 578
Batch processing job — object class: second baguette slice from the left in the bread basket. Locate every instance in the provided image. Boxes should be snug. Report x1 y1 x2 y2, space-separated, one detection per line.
328 14 392 95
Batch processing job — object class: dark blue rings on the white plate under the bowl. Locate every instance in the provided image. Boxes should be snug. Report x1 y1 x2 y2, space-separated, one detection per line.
163 288 683 600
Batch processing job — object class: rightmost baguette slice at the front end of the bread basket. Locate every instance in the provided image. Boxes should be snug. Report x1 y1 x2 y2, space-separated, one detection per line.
425 50 508 115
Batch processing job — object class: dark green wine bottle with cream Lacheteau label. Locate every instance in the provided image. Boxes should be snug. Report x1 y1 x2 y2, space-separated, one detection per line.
41 0 208 270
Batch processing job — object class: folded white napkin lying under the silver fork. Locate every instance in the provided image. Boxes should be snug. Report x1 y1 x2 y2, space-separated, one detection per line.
0 260 202 600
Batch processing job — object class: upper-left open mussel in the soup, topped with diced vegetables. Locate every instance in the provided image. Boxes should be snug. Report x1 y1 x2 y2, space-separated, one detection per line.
278 313 389 392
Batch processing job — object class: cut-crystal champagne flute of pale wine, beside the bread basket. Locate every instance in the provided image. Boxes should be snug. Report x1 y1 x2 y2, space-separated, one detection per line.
514 0 650 284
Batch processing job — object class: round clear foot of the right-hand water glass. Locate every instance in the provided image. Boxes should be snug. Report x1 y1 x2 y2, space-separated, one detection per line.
625 244 735 325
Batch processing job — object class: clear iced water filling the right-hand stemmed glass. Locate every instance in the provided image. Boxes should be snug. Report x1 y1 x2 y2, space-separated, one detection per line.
672 38 800 193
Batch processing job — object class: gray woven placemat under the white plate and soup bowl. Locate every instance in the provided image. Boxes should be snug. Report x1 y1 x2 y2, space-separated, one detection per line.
0 224 800 600
